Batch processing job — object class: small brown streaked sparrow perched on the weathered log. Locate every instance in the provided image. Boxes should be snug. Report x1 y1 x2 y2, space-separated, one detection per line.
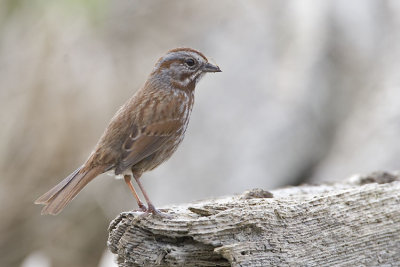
35 48 221 215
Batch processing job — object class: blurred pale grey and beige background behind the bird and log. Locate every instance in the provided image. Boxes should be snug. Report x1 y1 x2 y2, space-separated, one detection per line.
0 0 400 267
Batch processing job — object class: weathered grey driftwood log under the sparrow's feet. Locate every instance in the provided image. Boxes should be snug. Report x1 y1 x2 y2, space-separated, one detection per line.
108 173 400 266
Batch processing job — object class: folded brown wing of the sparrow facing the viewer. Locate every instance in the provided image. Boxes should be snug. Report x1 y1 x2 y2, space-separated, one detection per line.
115 119 182 174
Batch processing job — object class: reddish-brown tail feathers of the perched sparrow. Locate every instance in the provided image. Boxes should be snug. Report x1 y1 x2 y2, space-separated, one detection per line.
35 165 102 215
